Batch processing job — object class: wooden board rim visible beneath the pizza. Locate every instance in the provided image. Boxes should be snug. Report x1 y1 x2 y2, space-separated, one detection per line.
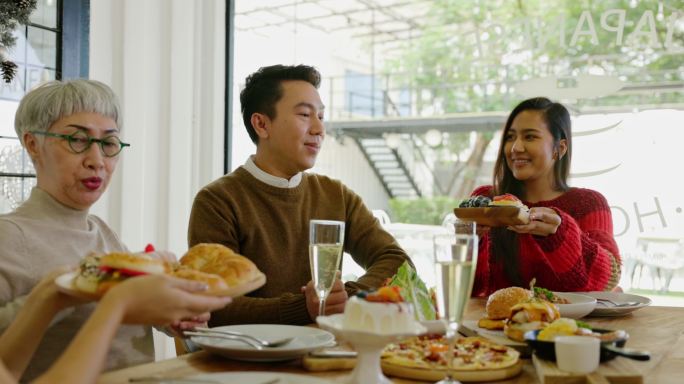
380 360 523 382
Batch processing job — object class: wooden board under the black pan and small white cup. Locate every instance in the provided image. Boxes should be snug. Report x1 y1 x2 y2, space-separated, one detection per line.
532 355 644 384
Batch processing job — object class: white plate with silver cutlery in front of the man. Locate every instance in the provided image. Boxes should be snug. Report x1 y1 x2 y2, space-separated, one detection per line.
191 324 335 362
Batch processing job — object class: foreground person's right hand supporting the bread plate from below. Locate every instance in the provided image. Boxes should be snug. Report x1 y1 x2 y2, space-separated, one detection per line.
100 275 231 326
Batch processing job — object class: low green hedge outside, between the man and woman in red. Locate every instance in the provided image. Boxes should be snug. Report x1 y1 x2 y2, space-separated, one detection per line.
389 196 460 225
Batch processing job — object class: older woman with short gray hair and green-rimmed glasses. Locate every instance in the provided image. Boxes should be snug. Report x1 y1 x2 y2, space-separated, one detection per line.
0 80 208 380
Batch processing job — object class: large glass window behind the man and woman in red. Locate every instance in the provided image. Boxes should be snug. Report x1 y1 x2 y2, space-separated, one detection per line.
230 0 684 291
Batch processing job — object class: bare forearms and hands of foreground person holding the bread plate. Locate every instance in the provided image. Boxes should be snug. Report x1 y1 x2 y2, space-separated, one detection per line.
0 269 230 384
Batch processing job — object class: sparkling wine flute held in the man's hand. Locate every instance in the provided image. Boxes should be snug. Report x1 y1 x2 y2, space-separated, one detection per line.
309 220 344 316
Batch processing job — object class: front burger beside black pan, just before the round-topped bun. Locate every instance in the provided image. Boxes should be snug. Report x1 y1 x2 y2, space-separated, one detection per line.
504 300 560 341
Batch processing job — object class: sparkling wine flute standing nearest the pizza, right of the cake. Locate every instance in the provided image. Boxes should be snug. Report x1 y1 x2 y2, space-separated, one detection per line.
433 219 478 384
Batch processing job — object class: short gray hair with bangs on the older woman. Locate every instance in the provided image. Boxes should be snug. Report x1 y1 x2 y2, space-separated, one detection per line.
14 79 121 145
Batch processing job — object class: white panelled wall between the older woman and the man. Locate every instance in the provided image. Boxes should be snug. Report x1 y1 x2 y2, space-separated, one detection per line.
90 0 226 357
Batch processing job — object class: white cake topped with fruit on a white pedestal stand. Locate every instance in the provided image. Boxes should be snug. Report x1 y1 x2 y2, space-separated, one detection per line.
316 286 426 384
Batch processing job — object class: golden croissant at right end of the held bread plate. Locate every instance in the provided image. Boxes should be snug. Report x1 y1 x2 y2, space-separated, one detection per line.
180 243 259 287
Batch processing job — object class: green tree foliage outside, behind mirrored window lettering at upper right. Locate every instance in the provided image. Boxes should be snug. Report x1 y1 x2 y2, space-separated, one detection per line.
384 0 684 113
